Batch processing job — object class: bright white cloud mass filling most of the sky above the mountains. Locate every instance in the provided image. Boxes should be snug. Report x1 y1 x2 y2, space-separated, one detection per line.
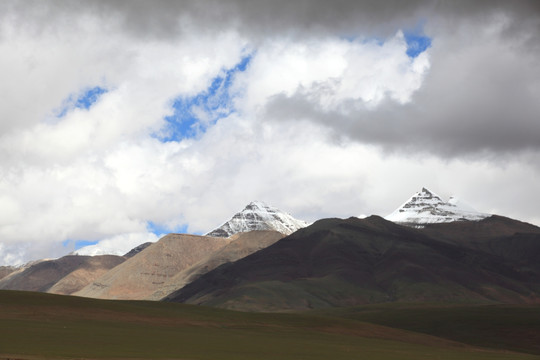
0 2 540 265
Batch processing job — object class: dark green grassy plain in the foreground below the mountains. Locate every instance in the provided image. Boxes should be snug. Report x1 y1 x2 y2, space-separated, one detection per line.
0 291 540 360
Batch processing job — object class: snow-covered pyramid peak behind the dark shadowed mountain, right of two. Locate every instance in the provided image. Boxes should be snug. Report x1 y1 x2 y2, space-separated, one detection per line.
385 188 490 225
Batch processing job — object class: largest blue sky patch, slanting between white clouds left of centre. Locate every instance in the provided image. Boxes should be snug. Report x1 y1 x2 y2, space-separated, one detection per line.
160 55 252 142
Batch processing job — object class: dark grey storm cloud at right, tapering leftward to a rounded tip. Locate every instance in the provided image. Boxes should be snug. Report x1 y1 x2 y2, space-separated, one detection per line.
266 42 540 158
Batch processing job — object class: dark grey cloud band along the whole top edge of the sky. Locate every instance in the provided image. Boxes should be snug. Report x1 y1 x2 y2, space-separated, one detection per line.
1 0 540 37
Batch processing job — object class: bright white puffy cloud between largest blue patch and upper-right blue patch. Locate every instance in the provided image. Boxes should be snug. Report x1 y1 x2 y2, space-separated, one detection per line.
237 31 430 116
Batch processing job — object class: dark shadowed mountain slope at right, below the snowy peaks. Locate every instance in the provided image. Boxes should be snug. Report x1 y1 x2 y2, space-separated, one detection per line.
167 216 540 311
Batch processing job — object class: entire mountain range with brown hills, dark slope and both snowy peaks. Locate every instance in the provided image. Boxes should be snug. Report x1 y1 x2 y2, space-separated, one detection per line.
0 188 540 311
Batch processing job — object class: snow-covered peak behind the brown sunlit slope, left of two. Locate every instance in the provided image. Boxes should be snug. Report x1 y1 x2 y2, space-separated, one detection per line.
206 201 308 237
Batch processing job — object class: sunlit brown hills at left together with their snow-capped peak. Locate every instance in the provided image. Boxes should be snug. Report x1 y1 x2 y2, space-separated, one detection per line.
0 202 298 300
